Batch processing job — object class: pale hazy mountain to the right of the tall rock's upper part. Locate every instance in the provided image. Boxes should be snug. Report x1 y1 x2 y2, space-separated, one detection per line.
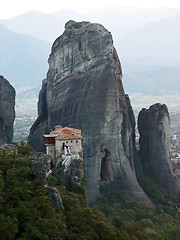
118 14 180 60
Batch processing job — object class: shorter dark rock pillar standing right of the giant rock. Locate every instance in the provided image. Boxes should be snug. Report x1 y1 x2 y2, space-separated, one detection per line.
138 103 180 197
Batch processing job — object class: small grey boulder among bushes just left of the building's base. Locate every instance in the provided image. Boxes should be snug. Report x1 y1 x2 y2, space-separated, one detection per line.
29 152 52 179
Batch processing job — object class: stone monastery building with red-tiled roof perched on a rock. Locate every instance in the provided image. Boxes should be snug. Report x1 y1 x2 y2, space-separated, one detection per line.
44 125 82 165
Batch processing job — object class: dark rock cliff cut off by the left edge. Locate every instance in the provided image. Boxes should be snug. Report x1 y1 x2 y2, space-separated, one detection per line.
0 76 15 145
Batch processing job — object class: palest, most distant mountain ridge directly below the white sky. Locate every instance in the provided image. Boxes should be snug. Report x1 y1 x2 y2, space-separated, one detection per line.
0 7 180 44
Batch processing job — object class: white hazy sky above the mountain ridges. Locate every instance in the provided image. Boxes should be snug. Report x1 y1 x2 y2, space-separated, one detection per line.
0 0 180 19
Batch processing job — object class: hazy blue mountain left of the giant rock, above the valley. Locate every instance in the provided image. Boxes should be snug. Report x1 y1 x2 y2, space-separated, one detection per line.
0 24 50 87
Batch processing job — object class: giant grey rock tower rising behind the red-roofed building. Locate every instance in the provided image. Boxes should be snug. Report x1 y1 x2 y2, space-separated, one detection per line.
29 21 151 205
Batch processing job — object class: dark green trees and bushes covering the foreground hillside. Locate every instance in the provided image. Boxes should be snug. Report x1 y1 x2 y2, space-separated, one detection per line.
0 143 180 240
